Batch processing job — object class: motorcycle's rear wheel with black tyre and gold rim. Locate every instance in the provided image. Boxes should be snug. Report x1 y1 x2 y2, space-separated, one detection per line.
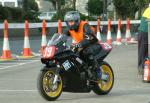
93 61 114 95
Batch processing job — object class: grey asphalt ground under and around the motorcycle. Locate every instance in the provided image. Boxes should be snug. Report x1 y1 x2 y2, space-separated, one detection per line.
0 45 150 103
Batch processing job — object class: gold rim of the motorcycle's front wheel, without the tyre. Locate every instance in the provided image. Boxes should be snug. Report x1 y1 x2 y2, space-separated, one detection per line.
43 71 62 97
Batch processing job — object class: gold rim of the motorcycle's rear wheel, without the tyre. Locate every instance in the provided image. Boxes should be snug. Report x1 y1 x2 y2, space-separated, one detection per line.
98 65 113 91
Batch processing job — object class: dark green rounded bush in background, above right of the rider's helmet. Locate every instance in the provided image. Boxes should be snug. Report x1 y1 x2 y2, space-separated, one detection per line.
86 0 103 15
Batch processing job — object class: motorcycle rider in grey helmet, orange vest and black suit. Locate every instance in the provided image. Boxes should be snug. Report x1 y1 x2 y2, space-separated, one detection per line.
64 11 98 80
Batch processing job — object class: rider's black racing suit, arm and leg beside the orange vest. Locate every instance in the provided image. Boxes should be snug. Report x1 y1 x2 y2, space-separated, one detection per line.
66 23 98 66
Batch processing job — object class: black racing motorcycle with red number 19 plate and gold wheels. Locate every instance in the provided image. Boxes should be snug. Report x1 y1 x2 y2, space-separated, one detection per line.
37 34 114 101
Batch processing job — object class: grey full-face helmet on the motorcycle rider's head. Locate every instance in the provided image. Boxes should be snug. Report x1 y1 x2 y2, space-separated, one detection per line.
64 11 80 30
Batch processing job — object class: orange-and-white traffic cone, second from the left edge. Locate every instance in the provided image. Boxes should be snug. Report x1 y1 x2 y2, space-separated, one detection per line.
22 20 32 58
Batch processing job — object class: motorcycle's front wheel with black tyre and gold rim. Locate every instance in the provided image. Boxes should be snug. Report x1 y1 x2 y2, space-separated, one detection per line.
37 69 62 101
